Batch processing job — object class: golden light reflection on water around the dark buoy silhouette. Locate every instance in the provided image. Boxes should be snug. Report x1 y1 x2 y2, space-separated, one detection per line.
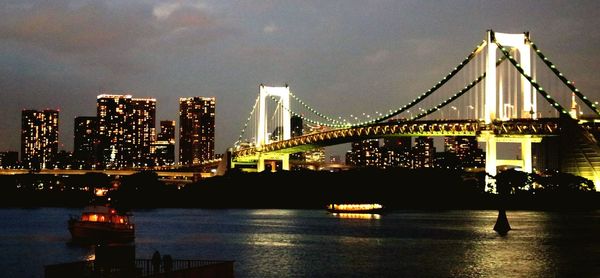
451 211 552 277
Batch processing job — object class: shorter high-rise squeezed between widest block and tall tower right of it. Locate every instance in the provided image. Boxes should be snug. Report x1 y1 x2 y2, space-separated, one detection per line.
151 121 175 166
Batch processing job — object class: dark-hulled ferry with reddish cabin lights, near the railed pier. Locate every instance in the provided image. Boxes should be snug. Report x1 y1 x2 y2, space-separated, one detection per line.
69 205 135 242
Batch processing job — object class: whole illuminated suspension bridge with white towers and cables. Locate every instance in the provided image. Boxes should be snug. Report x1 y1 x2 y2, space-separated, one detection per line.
227 30 600 187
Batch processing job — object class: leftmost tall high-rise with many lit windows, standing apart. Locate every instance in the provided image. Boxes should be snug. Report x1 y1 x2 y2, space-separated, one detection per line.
21 109 58 169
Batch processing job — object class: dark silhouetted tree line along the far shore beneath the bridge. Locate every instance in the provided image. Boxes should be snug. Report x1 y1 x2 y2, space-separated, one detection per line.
0 169 600 209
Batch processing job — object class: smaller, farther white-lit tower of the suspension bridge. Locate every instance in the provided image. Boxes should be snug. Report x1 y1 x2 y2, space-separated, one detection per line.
255 84 292 172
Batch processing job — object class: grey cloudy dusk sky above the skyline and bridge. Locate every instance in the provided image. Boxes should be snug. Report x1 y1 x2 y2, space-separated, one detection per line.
0 0 600 159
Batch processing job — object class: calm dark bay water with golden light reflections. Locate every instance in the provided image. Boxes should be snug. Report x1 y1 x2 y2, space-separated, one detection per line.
0 208 600 277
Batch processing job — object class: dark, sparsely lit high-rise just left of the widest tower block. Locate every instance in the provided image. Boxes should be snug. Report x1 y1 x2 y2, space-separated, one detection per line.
73 117 99 169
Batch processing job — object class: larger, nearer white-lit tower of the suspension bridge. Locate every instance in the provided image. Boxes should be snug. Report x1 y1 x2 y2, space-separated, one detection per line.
479 30 539 189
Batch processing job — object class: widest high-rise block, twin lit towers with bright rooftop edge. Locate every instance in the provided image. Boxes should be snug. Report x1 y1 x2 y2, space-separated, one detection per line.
97 94 156 168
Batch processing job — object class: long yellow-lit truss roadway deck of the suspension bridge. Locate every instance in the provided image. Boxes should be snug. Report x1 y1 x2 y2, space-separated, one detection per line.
232 118 560 162
